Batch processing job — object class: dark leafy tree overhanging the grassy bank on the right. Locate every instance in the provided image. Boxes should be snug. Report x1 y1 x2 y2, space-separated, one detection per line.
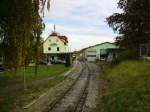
107 0 150 57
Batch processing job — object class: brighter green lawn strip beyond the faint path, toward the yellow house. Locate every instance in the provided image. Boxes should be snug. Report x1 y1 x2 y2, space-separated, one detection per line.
0 65 69 87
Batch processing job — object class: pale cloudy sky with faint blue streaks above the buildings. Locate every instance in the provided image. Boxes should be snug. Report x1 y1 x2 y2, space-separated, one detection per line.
43 0 119 51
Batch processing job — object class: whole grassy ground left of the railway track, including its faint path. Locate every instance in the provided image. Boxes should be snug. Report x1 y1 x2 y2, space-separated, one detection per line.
0 65 69 112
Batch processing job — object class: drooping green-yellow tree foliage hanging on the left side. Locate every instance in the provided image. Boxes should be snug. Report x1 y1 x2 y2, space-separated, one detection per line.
0 0 50 69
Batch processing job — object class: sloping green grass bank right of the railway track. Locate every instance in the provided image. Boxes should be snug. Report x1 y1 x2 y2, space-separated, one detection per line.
99 60 150 112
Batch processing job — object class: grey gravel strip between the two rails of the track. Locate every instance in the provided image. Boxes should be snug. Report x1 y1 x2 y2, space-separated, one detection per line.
48 62 88 112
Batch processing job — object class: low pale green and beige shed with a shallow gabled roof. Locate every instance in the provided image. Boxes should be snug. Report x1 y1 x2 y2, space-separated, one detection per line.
81 42 119 62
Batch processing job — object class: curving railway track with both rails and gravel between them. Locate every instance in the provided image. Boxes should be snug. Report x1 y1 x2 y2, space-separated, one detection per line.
43 62 90 112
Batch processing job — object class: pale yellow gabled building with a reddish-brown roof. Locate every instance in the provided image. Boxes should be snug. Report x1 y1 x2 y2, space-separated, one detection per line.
43 31 69 62
